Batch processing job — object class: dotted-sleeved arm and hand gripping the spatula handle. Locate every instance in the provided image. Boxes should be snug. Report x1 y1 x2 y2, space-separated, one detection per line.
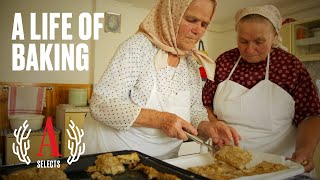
90 35 197 140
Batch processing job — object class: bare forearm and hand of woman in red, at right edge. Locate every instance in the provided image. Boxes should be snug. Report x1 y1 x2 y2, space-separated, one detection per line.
292 116 320 172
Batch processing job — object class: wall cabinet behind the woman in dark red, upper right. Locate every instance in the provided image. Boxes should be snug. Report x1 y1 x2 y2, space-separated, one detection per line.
280 18 320 61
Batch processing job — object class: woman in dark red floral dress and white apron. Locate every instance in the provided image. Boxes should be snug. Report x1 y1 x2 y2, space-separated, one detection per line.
202 5 320 171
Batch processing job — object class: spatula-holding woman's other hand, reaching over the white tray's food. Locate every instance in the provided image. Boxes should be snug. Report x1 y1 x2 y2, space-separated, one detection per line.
198 121 241 147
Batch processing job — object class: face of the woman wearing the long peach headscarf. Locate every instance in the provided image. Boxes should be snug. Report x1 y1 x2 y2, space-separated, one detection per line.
177 0 214 50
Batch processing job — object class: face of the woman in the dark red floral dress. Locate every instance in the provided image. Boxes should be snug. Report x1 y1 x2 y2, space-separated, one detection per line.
237 20 276 63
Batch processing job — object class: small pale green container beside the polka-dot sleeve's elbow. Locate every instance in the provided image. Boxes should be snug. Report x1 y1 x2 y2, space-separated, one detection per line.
68 88 87 106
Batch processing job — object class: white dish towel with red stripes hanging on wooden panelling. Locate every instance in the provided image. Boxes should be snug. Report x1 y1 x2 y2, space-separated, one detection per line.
8 87 45 115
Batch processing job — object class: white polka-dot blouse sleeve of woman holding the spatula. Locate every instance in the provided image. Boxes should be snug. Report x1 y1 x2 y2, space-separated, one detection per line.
90 35 148 130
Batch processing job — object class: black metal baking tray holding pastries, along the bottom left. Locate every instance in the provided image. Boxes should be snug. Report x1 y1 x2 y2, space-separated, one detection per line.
0 150 207 180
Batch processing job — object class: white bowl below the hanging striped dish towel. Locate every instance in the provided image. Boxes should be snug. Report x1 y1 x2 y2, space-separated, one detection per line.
9 114 44 131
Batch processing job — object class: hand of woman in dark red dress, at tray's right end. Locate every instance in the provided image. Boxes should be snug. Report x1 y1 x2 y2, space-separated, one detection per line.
291 148 314 172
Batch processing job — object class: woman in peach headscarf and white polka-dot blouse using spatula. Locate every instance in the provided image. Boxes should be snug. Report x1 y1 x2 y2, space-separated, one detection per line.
84 0 237 159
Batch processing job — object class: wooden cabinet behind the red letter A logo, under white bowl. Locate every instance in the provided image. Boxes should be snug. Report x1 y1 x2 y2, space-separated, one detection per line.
5 129 60 165
